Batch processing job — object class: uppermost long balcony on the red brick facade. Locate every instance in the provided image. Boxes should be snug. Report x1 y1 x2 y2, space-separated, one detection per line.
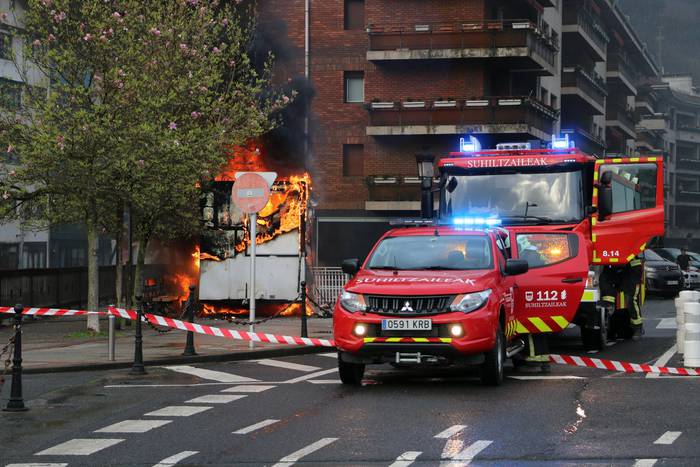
367 20 559 76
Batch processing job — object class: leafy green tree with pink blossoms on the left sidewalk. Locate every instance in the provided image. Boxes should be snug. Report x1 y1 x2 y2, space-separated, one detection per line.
0 0 290 327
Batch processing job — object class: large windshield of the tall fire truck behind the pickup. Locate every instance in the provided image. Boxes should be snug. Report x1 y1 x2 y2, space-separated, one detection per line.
442 170 584 224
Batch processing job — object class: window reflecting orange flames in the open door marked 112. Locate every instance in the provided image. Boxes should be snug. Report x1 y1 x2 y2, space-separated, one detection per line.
517 233 578 268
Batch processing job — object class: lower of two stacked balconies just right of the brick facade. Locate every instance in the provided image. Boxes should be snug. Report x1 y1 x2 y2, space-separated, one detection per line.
561 66 608 115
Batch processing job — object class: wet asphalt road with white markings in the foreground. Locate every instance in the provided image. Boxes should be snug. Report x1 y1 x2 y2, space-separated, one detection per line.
0 300 700 467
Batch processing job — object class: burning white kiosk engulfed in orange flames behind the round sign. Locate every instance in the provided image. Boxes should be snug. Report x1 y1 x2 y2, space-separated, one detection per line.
199 144 311 315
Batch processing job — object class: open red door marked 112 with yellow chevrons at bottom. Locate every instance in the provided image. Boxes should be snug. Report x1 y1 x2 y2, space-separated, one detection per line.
511 231 589 334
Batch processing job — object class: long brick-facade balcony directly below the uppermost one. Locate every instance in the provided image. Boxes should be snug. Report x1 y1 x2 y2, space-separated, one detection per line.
367 96 558 140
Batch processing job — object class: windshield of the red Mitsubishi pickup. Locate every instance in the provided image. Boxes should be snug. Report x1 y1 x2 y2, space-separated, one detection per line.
367 235 493 270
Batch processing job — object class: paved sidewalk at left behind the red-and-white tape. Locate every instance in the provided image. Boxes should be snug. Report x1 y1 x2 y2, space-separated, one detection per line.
0 317 333 373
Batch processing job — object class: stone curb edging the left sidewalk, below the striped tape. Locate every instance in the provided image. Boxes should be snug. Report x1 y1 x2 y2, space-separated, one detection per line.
22 347 332 375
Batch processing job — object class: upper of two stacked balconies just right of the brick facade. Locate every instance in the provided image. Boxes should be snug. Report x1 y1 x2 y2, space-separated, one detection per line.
561 6 610 62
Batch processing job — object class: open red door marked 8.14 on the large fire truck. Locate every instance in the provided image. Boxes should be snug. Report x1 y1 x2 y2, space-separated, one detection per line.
591 157 664 265
